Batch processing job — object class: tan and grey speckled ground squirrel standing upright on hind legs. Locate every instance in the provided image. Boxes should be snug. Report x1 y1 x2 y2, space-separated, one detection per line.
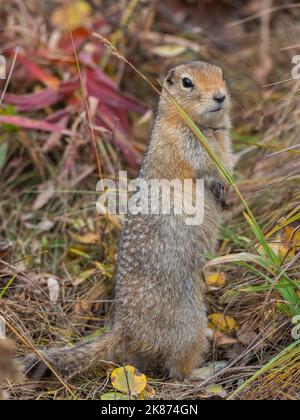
23 62 233 380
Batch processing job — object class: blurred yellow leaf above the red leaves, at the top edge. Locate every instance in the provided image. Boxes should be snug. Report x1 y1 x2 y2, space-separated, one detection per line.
51 0 91 30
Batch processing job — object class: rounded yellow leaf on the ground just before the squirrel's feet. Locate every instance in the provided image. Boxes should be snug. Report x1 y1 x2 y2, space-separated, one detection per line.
111 365 147 396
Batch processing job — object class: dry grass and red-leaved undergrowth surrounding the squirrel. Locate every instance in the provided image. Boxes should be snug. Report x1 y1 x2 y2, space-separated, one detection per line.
0 0 300 399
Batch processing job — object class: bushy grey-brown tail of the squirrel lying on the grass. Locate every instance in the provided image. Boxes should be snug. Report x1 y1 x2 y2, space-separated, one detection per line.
20 329 120 380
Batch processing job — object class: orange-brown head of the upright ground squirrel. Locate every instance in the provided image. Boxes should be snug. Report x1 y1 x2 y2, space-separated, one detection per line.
162 61 230 127
